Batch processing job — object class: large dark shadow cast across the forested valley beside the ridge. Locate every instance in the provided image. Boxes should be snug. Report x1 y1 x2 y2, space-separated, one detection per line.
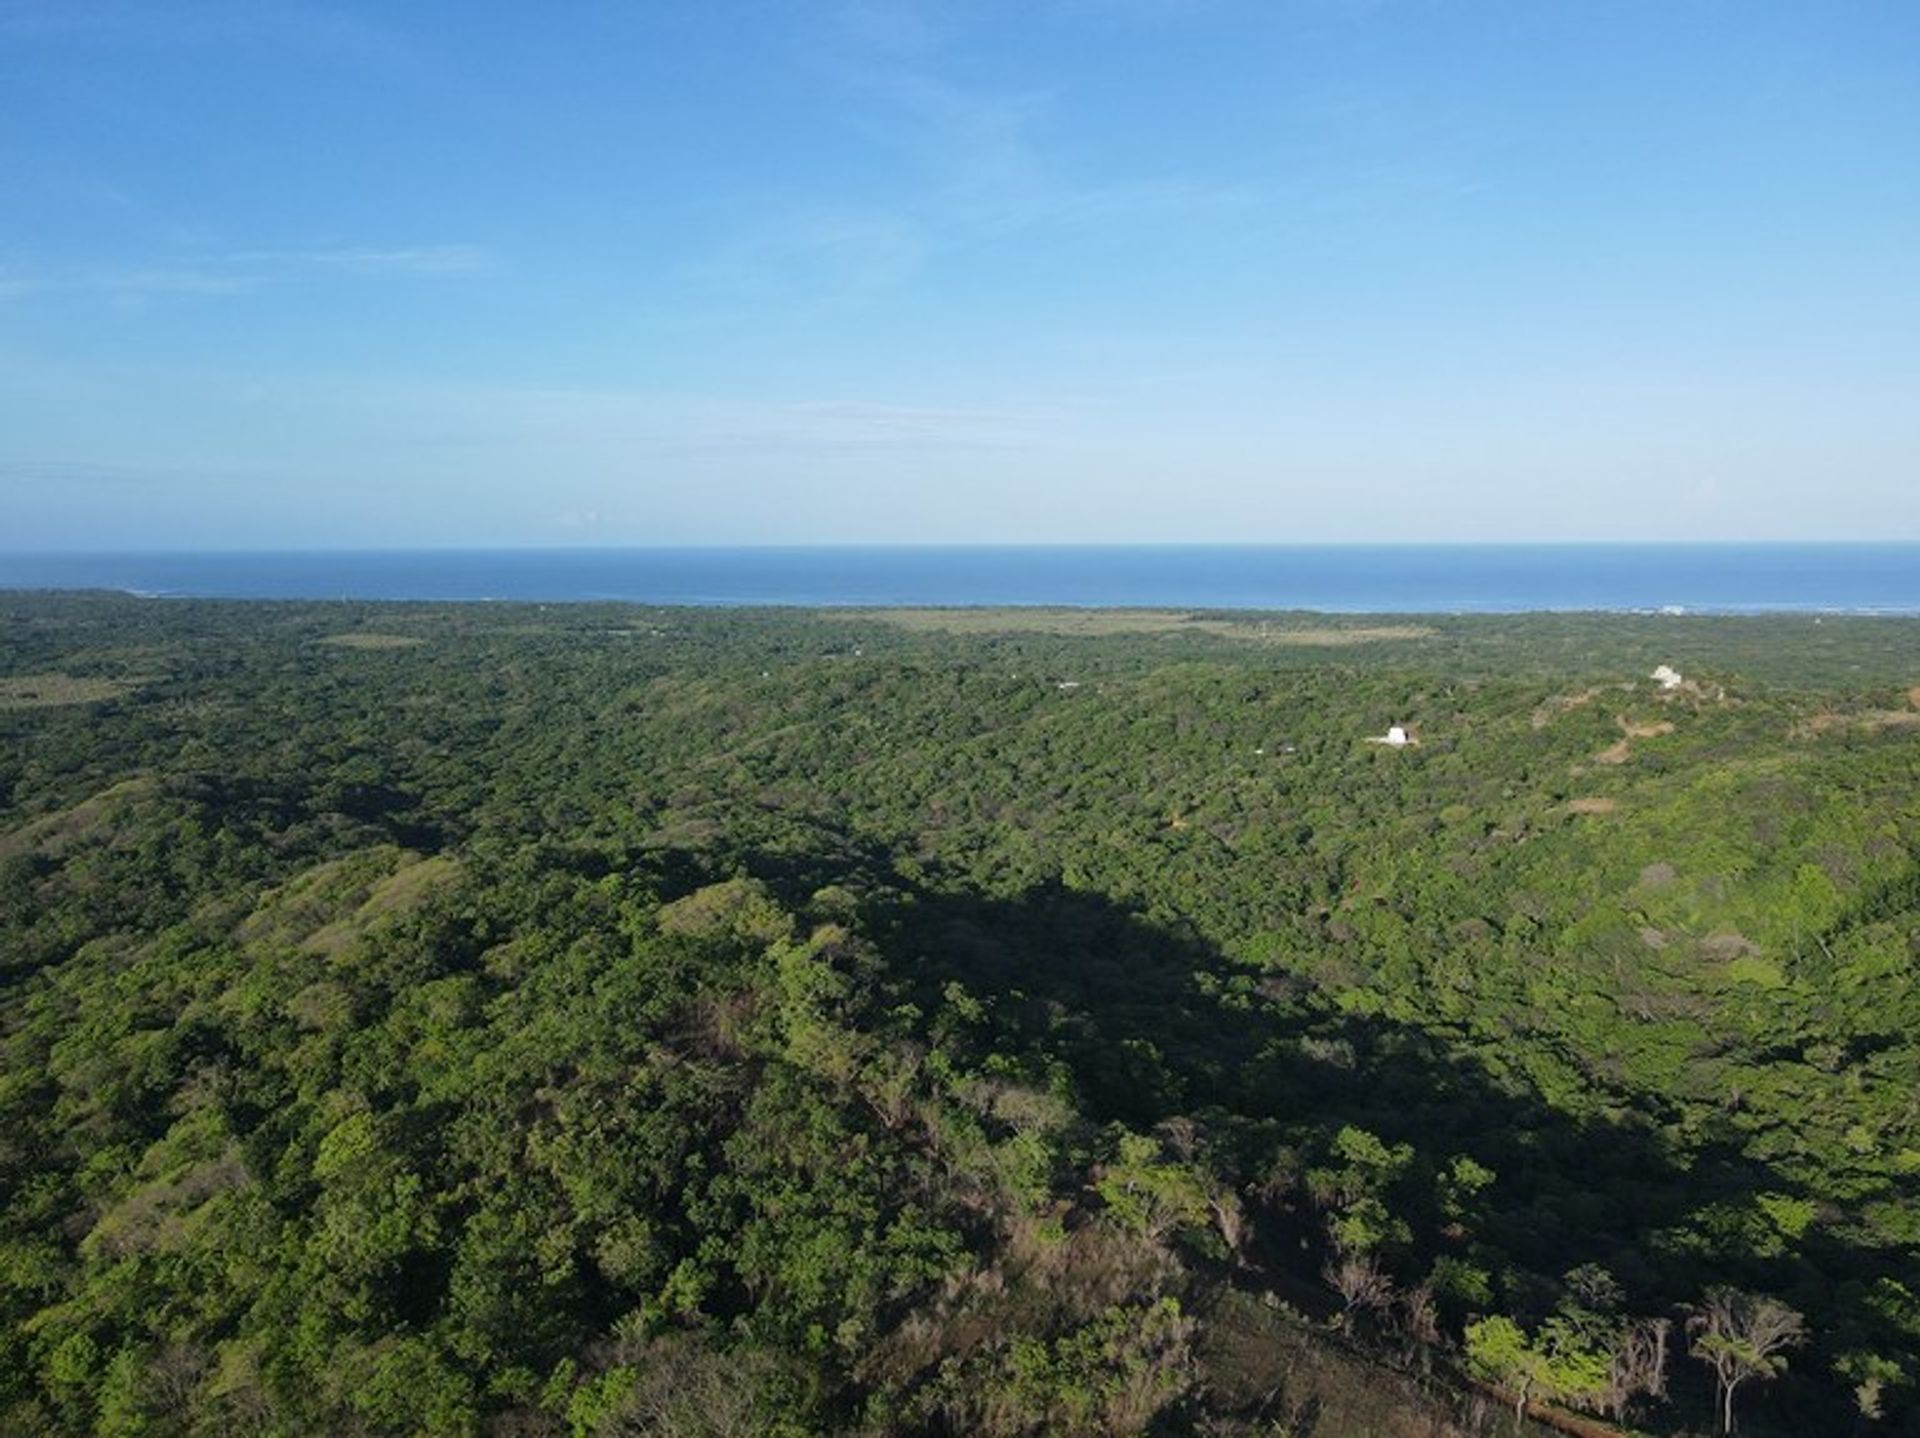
721 843 1858 1434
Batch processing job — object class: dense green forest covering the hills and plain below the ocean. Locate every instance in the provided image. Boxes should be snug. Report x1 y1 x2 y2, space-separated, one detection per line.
0 593 1920 1438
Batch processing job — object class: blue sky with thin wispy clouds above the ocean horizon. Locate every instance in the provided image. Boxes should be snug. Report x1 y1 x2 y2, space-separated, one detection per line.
0 0 1920 549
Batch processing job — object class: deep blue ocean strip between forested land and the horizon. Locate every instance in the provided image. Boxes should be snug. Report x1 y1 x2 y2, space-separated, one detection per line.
0 543 1920 614
